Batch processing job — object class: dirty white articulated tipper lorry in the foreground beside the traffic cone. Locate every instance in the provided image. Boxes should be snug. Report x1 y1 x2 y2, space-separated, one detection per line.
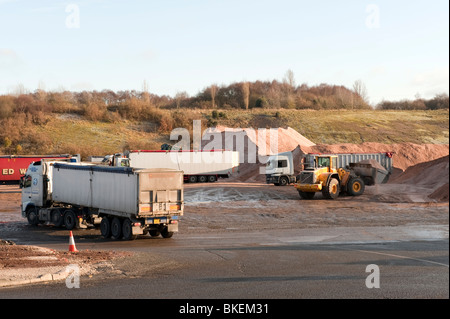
20 160 184 240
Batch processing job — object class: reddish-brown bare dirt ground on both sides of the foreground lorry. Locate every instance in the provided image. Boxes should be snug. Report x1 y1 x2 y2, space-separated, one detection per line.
0 181 449 290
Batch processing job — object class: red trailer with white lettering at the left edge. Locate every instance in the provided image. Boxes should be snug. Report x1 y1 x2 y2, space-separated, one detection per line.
0 154 71 184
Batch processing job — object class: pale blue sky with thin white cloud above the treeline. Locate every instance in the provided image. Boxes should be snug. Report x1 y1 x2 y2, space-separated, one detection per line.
0 0 449 104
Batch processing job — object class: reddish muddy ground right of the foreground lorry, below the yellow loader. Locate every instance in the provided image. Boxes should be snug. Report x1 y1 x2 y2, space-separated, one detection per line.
180 182 449 232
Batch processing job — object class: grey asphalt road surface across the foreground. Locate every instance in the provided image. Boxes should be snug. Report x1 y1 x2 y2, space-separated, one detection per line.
0 226 449 299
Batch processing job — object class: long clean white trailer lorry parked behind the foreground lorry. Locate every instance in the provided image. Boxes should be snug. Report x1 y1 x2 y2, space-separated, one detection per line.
104 150 239 183
